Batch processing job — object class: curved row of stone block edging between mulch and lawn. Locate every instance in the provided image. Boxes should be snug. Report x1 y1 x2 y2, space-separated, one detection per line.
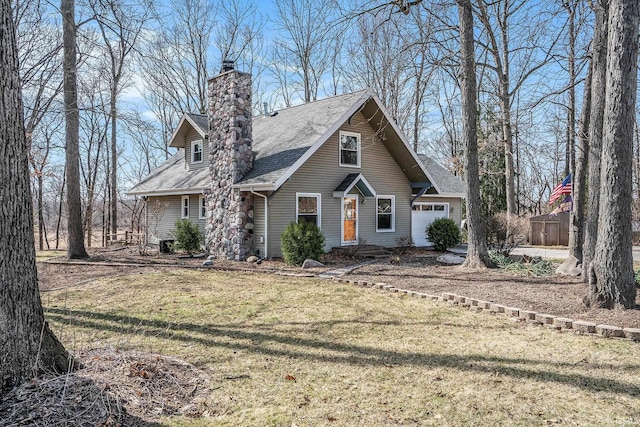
331 278 640 342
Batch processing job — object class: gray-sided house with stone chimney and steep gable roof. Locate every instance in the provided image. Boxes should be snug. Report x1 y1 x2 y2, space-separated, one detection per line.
128 67 464 260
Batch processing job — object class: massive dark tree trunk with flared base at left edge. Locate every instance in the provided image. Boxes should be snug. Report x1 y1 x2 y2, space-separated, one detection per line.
0 0 70 395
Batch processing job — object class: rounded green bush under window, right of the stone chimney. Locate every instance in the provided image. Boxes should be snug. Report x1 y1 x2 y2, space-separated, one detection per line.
281 221 324 265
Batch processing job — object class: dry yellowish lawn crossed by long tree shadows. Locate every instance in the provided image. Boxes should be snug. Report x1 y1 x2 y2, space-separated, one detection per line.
43 270 640 426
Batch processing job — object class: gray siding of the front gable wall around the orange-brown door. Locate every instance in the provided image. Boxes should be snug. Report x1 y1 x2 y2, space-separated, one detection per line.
269 113 411 257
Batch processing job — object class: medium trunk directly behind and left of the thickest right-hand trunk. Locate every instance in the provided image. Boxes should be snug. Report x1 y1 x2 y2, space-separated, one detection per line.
582 0 609 283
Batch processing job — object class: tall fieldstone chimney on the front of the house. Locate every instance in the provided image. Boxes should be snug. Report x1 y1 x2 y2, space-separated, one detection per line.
205 61 253 260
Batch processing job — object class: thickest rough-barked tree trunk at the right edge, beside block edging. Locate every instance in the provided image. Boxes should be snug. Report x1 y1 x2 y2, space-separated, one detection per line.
589 0 640 308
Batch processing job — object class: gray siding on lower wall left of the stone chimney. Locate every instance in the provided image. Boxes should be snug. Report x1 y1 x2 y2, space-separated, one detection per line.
147 194 205 244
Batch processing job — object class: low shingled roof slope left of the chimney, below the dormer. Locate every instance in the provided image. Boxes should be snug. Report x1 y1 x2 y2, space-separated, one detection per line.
127 150 209 196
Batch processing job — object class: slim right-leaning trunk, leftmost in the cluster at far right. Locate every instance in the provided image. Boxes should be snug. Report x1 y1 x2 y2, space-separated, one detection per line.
569 64 592 262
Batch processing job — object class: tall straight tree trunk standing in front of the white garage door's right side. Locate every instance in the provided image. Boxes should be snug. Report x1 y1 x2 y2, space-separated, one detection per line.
457 0 491 268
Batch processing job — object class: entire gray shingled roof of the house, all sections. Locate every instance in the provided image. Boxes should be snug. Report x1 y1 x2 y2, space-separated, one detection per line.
129 90 465 197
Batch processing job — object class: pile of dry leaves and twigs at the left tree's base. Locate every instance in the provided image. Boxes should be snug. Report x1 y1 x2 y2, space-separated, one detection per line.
0 347 212 427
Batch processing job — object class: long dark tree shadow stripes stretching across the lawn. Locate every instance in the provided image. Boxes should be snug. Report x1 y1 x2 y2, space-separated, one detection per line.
46 308 640 396
